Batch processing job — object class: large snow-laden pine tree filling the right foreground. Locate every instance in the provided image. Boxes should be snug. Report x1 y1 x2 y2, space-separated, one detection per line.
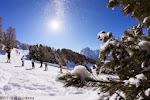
98 0 150 100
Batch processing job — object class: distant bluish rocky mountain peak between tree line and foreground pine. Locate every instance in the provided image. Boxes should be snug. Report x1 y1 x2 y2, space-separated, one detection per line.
80 47 99 60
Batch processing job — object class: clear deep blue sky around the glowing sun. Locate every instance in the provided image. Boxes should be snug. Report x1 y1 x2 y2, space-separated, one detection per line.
0 0 137 52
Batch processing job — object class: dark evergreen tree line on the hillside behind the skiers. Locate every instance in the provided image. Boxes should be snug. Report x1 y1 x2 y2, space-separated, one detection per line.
29 44 96 66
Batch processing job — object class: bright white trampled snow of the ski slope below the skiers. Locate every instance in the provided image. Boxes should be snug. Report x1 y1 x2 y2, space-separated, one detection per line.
0 49 98 100
